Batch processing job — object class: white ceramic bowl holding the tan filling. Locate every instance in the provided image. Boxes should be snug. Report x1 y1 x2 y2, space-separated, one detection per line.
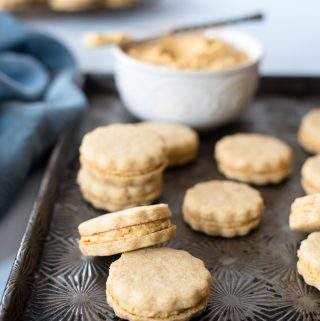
114 28 263 129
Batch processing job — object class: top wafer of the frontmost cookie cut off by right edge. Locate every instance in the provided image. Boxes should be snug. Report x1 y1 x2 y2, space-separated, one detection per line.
298 232 320 271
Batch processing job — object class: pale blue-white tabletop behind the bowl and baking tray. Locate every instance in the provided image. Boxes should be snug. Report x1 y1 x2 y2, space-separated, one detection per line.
19 0 320 75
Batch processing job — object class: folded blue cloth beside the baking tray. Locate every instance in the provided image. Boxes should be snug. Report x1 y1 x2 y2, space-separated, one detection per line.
0 13 86 214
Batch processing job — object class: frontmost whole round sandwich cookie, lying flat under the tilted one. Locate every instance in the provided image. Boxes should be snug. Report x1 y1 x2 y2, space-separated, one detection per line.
106 248 212 321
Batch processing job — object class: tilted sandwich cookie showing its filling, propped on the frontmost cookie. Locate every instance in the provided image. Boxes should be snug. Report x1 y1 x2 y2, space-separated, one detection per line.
79 204 176 256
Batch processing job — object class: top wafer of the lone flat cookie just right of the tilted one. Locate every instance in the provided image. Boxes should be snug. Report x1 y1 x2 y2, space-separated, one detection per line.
183 180 264 224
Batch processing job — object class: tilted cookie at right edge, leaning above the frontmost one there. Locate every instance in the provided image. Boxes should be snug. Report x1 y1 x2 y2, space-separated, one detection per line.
289 194 320 232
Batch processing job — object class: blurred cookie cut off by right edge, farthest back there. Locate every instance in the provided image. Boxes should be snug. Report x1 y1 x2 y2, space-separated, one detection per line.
298 108 320 154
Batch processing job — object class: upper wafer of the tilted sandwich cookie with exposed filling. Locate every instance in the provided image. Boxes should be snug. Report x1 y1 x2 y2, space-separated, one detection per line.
78 204 171 236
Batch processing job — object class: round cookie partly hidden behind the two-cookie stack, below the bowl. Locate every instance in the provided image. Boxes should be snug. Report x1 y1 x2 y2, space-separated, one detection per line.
139 122 199 166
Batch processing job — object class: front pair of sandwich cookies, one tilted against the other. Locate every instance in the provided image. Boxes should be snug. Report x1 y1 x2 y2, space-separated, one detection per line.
79 204 212 321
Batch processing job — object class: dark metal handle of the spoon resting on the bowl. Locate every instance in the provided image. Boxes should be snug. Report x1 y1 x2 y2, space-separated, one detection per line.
170 13 263 34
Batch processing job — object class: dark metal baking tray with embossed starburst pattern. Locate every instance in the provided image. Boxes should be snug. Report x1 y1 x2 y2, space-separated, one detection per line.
0 77 320 321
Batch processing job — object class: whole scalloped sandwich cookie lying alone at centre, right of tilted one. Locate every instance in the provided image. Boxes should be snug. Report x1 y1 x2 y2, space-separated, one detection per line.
183 180 264 237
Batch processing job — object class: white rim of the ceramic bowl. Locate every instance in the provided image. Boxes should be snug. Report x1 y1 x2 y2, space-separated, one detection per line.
113 27 264 76
